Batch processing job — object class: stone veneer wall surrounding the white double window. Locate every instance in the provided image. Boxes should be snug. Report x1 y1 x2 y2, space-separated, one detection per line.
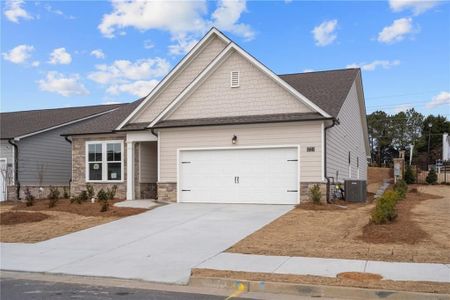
70 134 127 199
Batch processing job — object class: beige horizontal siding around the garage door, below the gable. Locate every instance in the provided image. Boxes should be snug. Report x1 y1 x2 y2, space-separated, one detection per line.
159 122 322 182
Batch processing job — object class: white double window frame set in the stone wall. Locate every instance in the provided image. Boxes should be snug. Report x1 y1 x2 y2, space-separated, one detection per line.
85 140 125 183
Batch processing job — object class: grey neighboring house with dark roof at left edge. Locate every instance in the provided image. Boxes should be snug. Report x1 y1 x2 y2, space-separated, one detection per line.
0 104 121 201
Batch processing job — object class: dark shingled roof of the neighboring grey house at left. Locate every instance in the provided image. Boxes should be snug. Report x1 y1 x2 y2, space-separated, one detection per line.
0 104 122 140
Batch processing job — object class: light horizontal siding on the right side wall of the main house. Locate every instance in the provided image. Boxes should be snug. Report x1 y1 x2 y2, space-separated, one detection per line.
327 82 367 180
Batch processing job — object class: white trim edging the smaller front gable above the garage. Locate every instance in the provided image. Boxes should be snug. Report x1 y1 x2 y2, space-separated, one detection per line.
147 42 331 128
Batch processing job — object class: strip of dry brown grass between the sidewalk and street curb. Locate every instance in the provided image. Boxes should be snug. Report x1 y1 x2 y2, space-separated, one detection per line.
191 269 450 294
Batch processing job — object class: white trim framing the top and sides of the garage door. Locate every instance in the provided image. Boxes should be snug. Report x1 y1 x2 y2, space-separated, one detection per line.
175 144 301 205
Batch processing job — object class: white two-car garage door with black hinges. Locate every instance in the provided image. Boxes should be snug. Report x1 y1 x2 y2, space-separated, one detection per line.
179 147 299 204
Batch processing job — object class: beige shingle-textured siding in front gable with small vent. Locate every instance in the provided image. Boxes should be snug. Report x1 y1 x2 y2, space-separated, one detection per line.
167 52 311 120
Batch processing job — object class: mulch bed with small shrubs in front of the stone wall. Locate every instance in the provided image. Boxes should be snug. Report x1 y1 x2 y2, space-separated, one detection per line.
11 199 147 218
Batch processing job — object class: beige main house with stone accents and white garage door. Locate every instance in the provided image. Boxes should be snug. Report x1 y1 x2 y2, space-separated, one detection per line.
64 28 369 204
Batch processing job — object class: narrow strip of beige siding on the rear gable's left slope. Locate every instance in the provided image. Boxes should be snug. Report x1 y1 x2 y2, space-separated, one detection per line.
130 37 226 123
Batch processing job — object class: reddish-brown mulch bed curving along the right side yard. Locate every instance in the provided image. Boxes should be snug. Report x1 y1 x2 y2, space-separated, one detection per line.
360 189 442 245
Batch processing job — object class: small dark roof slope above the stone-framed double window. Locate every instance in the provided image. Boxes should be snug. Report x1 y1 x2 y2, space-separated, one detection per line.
62 98 145 136
